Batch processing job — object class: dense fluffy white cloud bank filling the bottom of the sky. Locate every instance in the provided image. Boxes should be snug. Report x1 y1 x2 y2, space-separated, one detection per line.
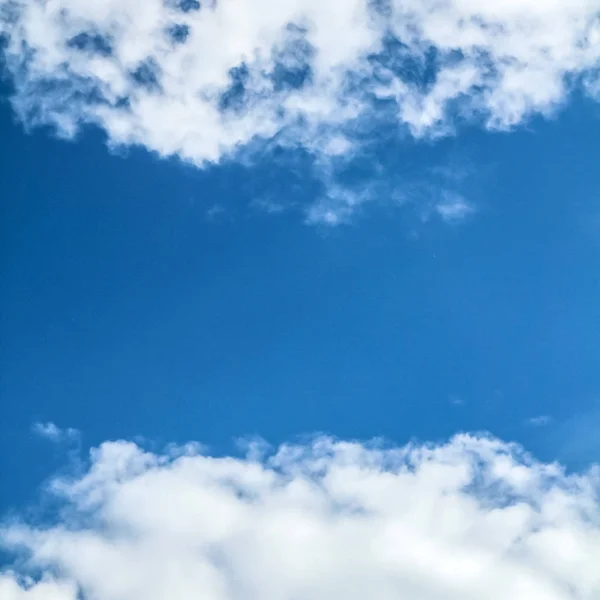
0 435 600 600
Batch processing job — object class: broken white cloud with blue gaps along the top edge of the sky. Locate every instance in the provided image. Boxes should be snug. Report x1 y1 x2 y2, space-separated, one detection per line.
0 0 600 221
